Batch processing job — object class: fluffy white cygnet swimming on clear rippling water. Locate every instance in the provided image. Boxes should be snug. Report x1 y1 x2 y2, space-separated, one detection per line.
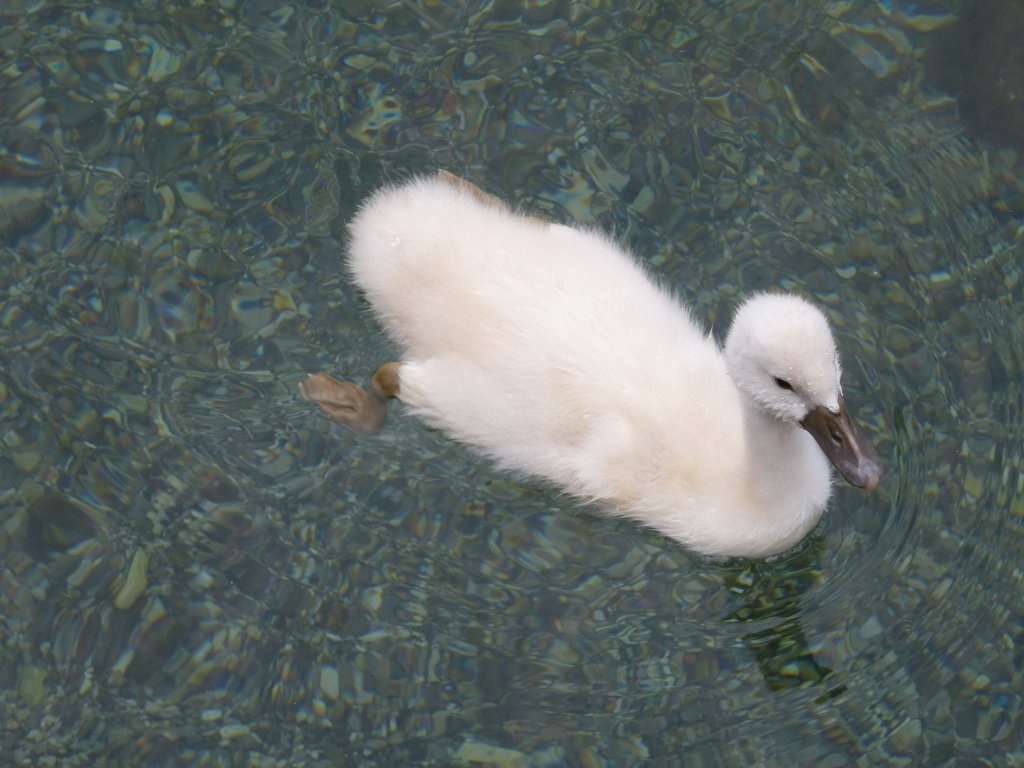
303 173 882 557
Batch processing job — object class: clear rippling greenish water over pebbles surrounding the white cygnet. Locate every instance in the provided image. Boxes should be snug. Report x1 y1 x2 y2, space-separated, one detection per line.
0 0 1024 766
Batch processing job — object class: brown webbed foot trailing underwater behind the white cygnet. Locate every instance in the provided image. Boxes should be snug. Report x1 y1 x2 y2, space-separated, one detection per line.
299 362 401 434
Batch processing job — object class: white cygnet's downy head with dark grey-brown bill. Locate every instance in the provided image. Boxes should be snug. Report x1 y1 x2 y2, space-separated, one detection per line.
725 294 882 490
